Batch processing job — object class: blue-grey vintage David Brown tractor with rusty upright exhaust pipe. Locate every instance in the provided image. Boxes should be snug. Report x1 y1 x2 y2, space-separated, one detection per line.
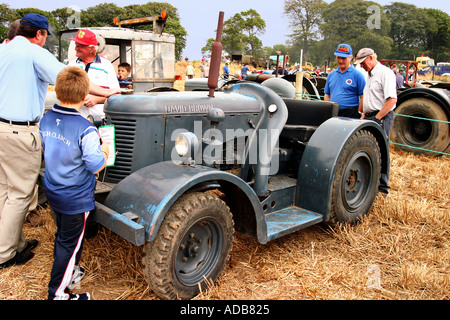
73 12 389 299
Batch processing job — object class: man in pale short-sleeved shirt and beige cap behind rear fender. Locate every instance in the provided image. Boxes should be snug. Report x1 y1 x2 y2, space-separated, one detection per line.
355 48 397 194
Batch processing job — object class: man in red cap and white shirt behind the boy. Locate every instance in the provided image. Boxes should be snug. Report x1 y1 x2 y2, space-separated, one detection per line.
69 30 120 119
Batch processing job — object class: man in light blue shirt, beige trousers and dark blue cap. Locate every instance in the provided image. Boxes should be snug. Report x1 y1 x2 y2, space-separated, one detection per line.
0 13 65 268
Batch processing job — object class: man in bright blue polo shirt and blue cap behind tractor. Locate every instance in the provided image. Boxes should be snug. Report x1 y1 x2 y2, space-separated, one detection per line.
324 43 366 119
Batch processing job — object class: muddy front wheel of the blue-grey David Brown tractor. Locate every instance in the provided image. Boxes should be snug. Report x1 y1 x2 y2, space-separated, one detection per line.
143 193 234 299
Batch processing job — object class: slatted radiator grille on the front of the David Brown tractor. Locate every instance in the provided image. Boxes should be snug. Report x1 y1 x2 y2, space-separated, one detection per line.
106 117 136 183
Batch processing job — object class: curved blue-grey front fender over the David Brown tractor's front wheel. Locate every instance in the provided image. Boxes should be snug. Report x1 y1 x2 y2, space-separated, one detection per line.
104 161 267 242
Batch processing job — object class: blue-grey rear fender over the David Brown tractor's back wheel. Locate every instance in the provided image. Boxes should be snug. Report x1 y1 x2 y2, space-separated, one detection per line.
296 117 389 221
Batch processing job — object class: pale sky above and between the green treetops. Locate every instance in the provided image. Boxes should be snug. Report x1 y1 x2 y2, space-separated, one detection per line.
0 0 450 60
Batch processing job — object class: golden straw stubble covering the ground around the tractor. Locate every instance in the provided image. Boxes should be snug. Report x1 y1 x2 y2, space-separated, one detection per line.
0 146 450 300
